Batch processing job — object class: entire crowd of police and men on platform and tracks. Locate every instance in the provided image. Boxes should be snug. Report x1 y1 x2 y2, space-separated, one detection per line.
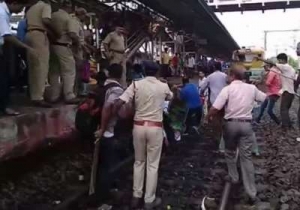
0 0 300 209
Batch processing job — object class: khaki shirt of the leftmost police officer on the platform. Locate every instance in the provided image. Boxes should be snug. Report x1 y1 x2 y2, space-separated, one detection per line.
26 1 51 31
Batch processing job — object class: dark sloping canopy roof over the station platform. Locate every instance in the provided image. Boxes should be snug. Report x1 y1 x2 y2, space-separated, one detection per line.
139 0 239 57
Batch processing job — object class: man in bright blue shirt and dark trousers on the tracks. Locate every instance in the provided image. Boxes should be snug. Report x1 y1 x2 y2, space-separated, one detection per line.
180 77 202 134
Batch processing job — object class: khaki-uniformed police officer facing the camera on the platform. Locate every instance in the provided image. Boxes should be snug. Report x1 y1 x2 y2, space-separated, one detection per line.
102 26 126 86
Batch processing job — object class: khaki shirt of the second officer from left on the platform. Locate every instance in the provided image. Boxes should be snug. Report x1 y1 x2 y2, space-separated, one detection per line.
51 9 77 44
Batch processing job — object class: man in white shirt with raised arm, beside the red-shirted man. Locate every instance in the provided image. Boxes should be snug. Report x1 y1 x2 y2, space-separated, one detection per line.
260 53 297 132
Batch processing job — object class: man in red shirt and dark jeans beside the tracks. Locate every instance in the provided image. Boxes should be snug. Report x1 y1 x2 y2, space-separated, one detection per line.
256 64 281 125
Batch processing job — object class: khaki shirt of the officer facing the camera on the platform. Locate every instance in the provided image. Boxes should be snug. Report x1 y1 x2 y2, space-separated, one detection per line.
103 32 125 53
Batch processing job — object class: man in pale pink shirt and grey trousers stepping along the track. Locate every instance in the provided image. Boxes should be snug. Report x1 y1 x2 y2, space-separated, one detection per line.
208 65 266 207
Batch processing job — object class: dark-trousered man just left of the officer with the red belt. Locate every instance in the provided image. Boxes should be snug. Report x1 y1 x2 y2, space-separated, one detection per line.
95 64 124 207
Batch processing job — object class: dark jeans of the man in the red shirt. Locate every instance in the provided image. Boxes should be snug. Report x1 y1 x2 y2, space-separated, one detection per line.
256 95 280 125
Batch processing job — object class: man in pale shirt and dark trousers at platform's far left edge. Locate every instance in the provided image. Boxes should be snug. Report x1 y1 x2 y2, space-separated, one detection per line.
0 0 34 115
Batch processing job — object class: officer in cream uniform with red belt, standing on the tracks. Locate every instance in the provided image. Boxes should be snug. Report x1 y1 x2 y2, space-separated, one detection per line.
115 61 173 209
